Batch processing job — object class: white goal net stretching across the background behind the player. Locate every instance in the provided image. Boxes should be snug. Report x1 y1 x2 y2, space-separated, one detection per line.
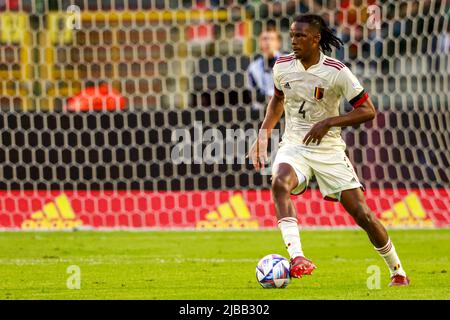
0 0 450 230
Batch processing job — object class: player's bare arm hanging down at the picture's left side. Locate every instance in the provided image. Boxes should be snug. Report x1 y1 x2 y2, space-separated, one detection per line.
249 86 284 171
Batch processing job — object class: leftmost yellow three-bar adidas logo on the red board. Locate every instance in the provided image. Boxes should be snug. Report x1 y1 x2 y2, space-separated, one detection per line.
21 195 83 230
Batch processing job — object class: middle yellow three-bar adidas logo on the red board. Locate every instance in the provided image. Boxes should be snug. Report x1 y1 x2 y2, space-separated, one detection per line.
195 194 259 229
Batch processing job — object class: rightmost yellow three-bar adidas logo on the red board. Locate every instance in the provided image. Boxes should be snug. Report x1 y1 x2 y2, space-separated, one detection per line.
381 192 434 227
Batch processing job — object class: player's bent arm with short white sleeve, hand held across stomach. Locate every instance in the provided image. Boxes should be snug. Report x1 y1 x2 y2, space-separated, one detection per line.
303 67 376 145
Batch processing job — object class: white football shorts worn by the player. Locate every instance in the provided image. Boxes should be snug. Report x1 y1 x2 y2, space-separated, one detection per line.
272 143 364 201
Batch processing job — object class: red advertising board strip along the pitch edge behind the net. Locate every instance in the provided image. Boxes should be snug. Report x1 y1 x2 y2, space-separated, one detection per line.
0 188 450 229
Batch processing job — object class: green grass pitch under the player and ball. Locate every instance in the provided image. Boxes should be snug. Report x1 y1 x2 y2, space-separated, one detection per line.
0 229 450 300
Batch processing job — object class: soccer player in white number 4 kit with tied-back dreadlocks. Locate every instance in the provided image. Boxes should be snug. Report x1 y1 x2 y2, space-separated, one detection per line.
250 15 409 286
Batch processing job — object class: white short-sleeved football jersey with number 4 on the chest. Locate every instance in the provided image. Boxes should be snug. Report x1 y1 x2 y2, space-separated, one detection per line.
273 52 368 150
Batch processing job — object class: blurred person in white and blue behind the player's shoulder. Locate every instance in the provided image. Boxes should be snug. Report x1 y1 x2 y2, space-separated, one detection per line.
248 28 281 109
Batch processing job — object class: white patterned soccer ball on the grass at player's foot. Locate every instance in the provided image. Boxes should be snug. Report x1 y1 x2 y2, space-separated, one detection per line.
256 254 291 288
